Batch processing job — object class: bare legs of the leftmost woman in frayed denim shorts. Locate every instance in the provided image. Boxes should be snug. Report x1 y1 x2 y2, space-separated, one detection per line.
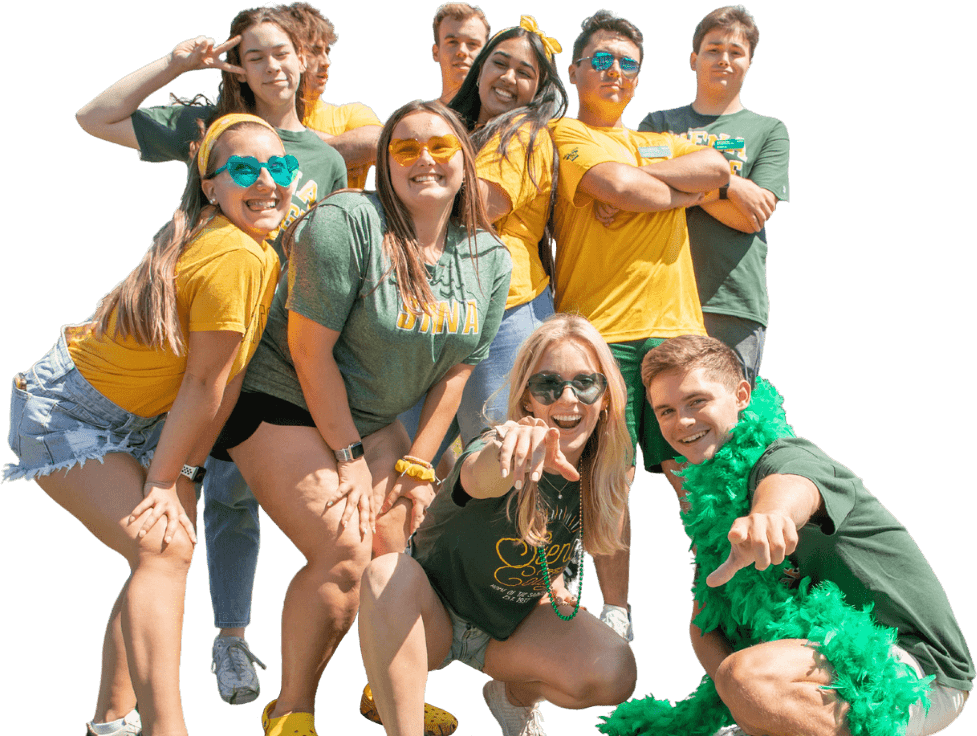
37 453 196 736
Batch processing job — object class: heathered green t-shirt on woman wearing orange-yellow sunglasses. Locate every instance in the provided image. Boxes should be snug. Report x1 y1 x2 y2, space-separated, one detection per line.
244 192 512 436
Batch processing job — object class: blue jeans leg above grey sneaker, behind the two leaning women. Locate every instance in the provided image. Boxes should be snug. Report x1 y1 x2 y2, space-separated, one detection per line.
204 457 261 629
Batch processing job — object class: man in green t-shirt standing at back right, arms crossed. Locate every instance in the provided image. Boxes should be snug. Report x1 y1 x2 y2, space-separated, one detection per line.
638 5 790 384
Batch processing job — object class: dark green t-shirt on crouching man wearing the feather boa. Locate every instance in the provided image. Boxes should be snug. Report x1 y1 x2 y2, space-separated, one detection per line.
748 437 974 692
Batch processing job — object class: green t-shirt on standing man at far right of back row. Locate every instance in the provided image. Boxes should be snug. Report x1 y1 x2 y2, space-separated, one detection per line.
638 105 790 326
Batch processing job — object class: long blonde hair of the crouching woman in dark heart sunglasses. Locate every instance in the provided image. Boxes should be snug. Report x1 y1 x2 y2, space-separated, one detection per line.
507 313 632 554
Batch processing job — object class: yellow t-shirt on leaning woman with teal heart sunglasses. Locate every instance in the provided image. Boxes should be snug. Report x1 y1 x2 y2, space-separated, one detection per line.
65 216 279 417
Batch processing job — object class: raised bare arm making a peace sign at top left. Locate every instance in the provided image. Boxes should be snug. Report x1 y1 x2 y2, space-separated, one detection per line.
75 36 244 150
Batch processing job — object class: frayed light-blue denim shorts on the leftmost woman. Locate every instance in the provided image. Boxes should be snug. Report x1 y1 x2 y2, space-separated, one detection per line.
3 328 166 481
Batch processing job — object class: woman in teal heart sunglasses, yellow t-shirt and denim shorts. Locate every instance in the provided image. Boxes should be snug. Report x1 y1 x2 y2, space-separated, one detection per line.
3 114 290 734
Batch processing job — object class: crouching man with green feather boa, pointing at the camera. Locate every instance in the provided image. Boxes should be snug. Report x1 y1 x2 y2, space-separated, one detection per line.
640 335 974 736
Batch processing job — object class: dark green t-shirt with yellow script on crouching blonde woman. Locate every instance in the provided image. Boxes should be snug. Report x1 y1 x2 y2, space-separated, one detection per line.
412 439 580 641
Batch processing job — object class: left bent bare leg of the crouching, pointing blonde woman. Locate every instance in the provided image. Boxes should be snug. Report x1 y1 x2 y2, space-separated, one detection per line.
359 554 451 736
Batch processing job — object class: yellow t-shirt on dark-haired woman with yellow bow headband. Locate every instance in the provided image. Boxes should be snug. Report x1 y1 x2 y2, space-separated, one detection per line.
475 123 554 309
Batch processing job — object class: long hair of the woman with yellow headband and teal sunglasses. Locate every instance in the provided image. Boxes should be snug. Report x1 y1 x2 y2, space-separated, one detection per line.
90 122 267 355
